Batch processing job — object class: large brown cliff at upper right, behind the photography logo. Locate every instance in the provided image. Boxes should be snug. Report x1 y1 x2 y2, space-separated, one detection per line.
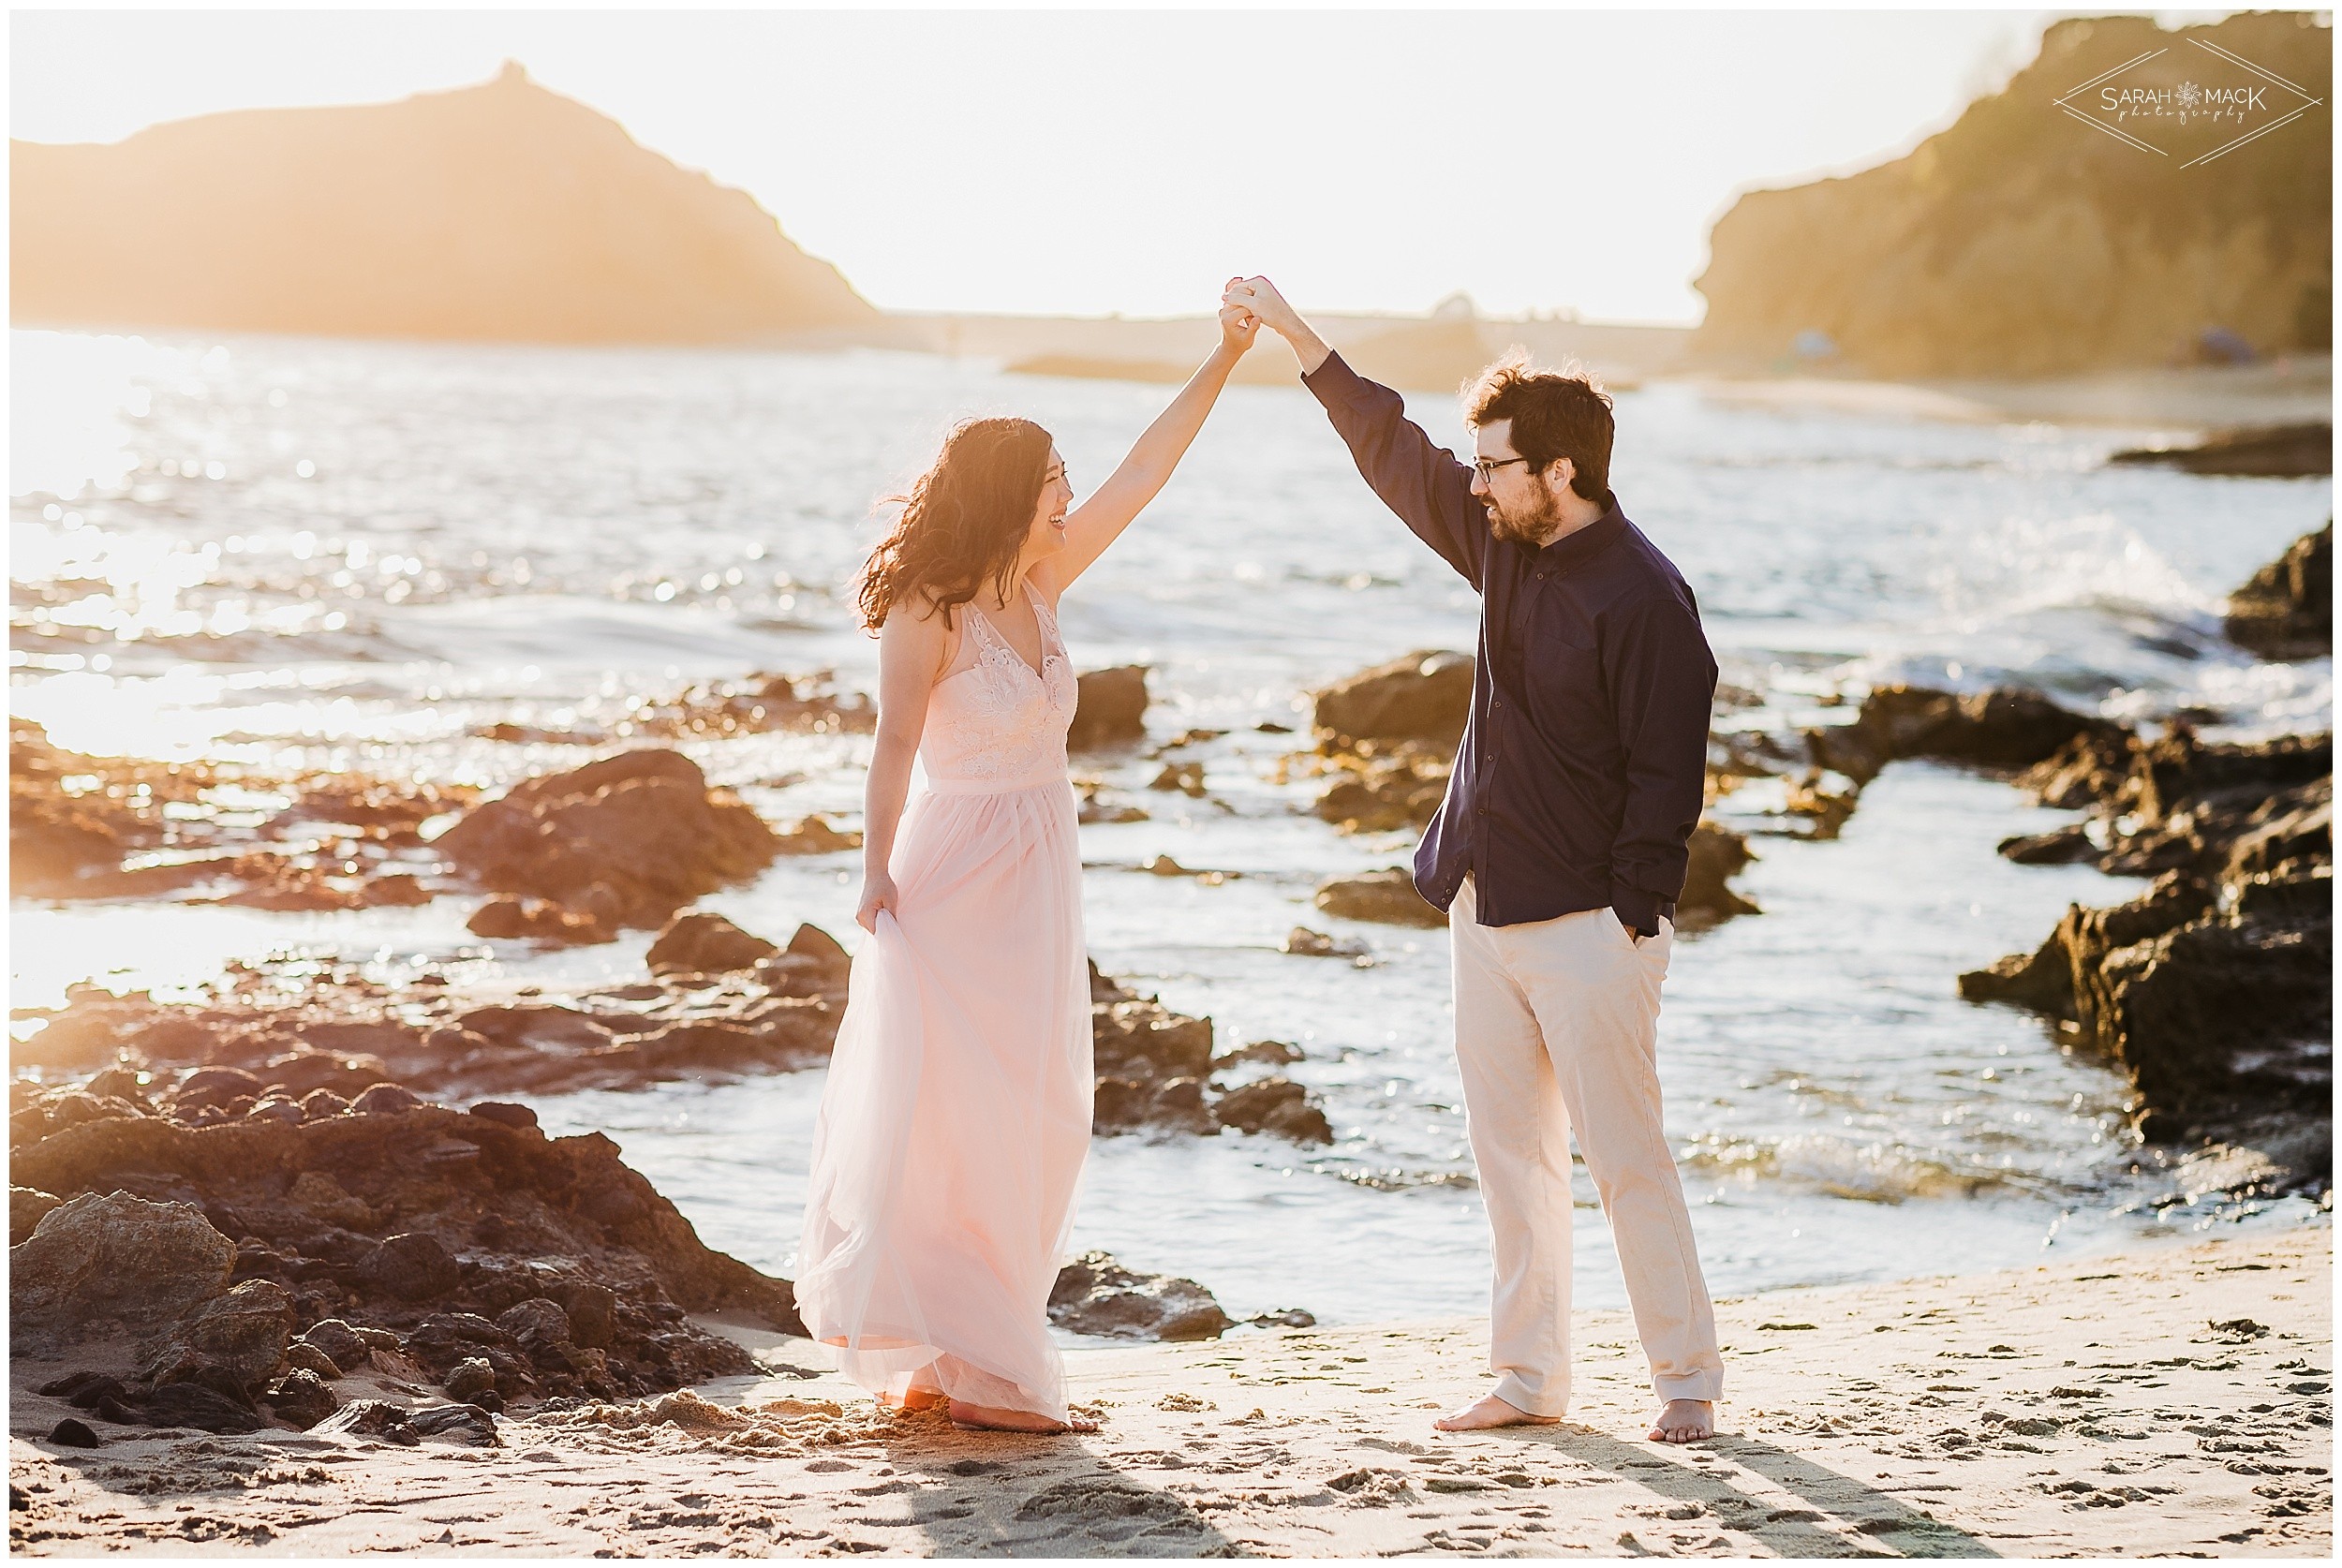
1694 11 2333 377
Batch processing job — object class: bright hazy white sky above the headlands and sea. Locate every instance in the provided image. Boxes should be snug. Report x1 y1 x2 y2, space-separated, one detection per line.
9 7 2223 323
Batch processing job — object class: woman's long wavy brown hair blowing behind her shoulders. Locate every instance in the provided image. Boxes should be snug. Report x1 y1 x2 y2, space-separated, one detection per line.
857 419 1052 632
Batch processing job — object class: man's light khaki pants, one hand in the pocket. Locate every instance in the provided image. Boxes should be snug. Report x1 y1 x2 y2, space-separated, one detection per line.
1447 878 1724 1416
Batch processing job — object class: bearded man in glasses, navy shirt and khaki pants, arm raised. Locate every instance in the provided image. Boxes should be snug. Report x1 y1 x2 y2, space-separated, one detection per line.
1227 278 1724 1442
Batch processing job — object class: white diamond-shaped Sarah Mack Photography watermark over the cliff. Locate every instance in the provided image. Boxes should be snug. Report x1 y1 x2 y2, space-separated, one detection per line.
2056 37 2326 169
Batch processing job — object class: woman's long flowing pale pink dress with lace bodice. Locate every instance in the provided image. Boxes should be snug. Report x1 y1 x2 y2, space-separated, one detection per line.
796 587 1091 1421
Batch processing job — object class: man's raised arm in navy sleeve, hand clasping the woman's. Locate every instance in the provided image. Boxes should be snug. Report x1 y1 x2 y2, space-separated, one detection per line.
1223 278 1490 587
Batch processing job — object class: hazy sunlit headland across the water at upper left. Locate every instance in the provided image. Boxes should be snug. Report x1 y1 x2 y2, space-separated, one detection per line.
9 66 879 344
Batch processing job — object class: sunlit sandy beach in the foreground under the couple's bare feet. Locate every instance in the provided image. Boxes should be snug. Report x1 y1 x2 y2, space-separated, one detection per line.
9 1226 2333 1557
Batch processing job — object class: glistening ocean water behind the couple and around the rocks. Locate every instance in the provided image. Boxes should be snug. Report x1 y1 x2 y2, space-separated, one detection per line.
9 333 2333 1323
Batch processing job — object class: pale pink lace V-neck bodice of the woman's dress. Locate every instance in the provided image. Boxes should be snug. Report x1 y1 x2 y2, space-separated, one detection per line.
918 583 1075 793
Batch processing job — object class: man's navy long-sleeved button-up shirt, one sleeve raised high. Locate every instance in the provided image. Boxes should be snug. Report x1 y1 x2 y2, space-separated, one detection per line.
1302 353 1717 931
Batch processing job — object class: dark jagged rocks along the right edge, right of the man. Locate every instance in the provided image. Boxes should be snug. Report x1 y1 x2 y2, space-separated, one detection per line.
1811 522 2333 1196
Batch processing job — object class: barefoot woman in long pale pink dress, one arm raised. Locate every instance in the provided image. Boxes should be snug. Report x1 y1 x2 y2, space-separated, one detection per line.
796 288 1255 1432
